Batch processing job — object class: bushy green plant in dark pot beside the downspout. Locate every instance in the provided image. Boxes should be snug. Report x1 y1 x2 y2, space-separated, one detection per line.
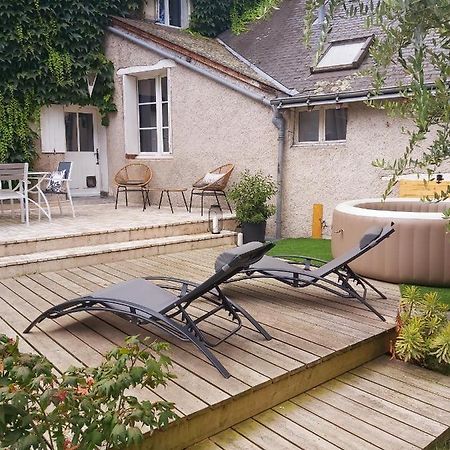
229 170 277 244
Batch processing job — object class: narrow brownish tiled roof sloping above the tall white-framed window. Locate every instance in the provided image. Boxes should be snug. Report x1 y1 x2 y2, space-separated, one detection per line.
113 18 276 93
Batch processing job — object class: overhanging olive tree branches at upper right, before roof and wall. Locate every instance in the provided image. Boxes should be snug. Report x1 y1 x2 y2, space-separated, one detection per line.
305 0 450 198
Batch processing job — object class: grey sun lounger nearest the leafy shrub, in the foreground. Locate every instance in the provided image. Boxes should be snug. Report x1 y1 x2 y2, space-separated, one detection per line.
24 242 273 378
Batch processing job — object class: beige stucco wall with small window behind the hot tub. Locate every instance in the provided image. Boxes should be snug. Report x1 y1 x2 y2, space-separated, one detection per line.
282 103 449 236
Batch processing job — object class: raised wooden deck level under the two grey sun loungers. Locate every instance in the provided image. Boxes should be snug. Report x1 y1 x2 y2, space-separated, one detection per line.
0 248 399 449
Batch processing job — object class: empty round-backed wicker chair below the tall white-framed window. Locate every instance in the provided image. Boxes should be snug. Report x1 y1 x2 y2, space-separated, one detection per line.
114 163 153 209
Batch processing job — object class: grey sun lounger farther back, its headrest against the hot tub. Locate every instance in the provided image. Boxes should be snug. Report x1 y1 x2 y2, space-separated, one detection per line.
220 223 394 321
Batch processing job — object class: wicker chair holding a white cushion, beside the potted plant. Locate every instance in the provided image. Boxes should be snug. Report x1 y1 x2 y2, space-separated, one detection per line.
189 164 234 216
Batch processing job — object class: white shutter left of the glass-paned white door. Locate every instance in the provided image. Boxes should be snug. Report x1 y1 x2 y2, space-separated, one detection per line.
41 105 66 153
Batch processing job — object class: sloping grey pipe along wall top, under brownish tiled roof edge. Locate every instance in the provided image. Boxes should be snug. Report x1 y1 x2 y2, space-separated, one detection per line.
108 26 271 106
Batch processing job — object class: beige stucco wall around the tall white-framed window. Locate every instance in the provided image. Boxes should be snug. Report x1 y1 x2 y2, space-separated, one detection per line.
106 35 278 233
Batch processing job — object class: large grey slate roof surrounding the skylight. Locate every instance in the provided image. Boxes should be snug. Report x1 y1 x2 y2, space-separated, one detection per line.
220 0 438 96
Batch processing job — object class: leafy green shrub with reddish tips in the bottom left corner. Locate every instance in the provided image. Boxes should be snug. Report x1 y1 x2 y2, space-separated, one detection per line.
0 335 176 450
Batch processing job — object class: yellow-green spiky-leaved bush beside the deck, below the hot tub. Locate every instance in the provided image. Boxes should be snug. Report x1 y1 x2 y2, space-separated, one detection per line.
394 286 450 374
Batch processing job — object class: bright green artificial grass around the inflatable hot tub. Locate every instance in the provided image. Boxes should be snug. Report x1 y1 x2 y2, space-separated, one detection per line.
269 238 450 308
